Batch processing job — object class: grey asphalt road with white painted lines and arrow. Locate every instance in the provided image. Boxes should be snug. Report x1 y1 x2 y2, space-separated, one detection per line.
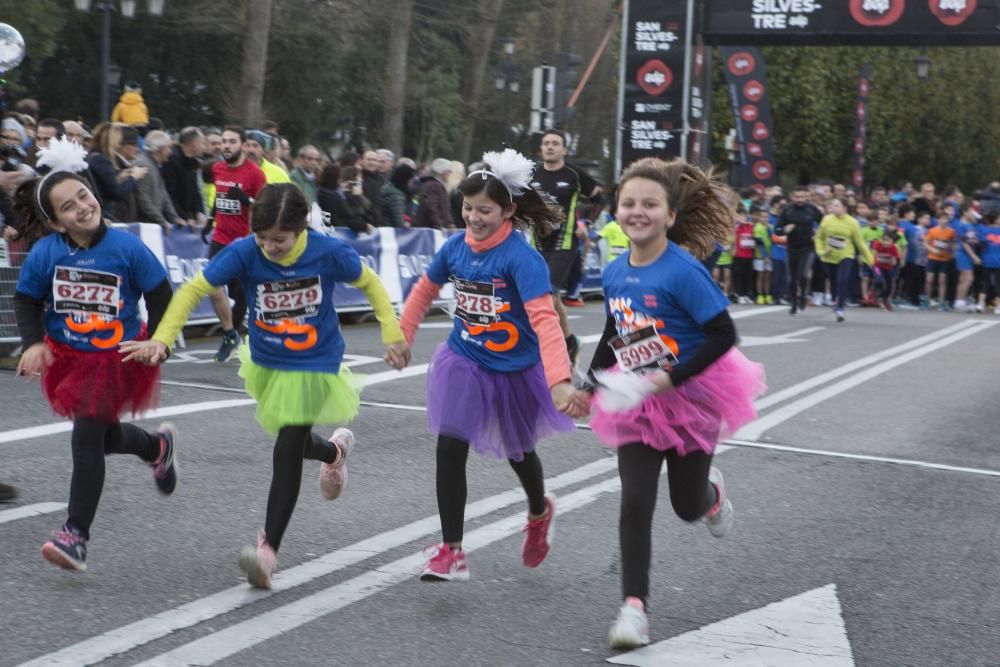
0 302 1000 667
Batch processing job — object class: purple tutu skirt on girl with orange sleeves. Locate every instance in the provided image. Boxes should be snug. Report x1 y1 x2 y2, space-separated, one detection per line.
427 343 576 461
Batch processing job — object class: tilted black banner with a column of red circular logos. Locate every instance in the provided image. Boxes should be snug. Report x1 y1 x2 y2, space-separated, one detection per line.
722 46 778 190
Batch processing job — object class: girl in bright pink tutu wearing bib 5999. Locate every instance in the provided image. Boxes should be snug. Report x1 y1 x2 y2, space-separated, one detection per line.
581 158 765 648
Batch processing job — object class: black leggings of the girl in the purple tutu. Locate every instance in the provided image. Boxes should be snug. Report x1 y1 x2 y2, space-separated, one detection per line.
437 435 545 544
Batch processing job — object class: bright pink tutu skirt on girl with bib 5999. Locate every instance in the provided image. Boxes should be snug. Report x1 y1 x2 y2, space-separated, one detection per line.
590 348 767 456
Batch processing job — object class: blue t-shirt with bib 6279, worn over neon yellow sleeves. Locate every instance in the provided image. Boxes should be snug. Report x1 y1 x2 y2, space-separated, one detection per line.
204 230 361 373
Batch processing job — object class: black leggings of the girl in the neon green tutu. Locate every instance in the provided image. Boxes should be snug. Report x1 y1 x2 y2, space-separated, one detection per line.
264 425 337 551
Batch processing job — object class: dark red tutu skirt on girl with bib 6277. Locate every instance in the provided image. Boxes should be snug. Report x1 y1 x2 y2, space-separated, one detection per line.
42 336 160 422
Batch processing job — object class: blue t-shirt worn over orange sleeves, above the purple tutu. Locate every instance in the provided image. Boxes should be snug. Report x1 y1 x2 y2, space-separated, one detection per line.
427 232 551 373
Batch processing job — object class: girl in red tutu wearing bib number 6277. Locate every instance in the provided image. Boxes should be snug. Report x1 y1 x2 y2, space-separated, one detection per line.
14 140 177 570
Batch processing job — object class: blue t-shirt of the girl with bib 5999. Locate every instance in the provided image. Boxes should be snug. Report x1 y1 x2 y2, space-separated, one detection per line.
604 243 729 363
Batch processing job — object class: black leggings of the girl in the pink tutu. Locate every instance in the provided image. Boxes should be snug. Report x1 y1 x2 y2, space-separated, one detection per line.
618 443 717 604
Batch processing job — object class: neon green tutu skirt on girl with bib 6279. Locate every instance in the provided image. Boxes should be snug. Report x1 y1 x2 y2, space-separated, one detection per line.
240 344 365 435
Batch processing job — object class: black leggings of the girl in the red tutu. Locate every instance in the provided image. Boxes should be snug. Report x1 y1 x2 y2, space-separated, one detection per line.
66 417 160 540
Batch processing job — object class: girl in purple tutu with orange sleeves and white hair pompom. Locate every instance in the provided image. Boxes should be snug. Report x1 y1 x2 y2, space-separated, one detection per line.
400 149 586 581
